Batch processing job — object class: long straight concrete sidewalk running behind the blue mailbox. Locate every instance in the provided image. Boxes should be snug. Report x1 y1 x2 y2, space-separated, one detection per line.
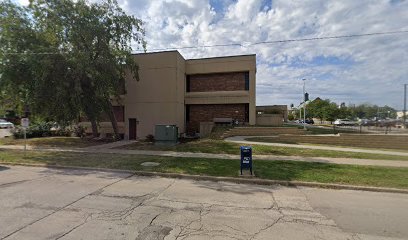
0 143 408 167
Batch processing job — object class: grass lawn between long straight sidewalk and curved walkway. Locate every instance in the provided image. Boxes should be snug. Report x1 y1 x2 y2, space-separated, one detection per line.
119 139 408 160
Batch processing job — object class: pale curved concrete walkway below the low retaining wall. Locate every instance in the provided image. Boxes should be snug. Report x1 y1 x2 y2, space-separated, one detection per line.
225 136 408 156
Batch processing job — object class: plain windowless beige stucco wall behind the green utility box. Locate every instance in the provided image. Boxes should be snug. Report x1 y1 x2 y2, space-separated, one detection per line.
124 51 185 138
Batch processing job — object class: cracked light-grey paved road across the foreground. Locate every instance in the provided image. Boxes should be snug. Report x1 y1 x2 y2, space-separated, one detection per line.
0 166 408 239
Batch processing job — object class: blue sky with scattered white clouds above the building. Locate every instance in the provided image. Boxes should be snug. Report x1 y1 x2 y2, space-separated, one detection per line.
18 0 408 109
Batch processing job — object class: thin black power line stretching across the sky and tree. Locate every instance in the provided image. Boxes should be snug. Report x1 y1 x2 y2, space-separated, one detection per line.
3 30 408 55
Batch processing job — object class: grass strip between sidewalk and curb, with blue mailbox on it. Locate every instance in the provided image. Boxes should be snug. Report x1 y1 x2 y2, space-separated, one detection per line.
0 150 408 189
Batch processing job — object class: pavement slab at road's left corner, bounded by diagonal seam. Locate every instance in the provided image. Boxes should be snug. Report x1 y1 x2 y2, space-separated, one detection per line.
0 167 128 239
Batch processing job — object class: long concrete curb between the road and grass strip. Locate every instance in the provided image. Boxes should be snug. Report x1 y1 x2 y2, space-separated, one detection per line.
0 162 408 194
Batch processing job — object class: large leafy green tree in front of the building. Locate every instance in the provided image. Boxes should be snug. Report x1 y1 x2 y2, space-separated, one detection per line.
0 0 145 136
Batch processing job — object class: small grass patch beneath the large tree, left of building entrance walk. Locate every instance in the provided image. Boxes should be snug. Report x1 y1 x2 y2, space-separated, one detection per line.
0 137 106 148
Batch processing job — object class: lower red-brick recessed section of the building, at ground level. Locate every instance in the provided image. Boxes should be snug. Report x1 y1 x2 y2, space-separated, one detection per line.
186 103 249 132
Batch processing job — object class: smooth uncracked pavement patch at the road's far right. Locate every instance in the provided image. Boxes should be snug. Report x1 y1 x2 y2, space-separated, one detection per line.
302 188 408 239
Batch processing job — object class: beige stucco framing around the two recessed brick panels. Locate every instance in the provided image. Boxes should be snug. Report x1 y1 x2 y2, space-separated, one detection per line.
185 55 256 125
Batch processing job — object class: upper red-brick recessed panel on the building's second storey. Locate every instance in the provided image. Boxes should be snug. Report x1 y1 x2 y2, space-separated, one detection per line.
186 72 248 92
